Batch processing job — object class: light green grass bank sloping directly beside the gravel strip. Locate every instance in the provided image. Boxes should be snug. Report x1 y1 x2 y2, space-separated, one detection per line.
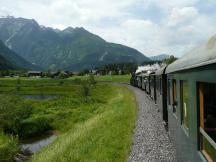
32 87 136 162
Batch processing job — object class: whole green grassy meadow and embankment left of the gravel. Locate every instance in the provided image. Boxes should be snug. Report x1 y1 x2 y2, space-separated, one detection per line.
0 76 136 162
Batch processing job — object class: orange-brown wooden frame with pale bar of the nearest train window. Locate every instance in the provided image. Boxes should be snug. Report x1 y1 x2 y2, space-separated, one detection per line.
197 82 216 161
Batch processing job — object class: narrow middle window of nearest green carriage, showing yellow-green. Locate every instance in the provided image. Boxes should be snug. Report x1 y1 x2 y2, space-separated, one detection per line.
181 81 189 130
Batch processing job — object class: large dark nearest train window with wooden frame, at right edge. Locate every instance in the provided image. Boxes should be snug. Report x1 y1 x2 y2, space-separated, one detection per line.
199 83 216 161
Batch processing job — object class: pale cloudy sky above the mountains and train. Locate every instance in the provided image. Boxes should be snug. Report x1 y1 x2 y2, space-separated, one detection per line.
0 0 216 57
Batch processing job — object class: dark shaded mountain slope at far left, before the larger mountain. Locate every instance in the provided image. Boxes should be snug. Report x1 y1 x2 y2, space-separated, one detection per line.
0 41 36 70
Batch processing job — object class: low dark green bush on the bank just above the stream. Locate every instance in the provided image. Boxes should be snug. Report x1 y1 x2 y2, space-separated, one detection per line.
19 116 52 138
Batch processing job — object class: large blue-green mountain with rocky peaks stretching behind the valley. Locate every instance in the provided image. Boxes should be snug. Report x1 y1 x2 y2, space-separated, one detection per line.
0 17 150 71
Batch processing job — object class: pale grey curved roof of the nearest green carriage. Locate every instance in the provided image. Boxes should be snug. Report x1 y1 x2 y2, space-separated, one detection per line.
166 35 216 73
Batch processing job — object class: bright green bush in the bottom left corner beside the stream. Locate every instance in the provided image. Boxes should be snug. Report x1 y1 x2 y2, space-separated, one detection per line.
0 132 19 162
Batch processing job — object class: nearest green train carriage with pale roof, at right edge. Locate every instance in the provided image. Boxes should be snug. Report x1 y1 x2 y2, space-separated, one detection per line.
166 36 216 162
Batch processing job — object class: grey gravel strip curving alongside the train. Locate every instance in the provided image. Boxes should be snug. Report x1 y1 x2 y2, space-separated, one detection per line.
125 85 176 162
